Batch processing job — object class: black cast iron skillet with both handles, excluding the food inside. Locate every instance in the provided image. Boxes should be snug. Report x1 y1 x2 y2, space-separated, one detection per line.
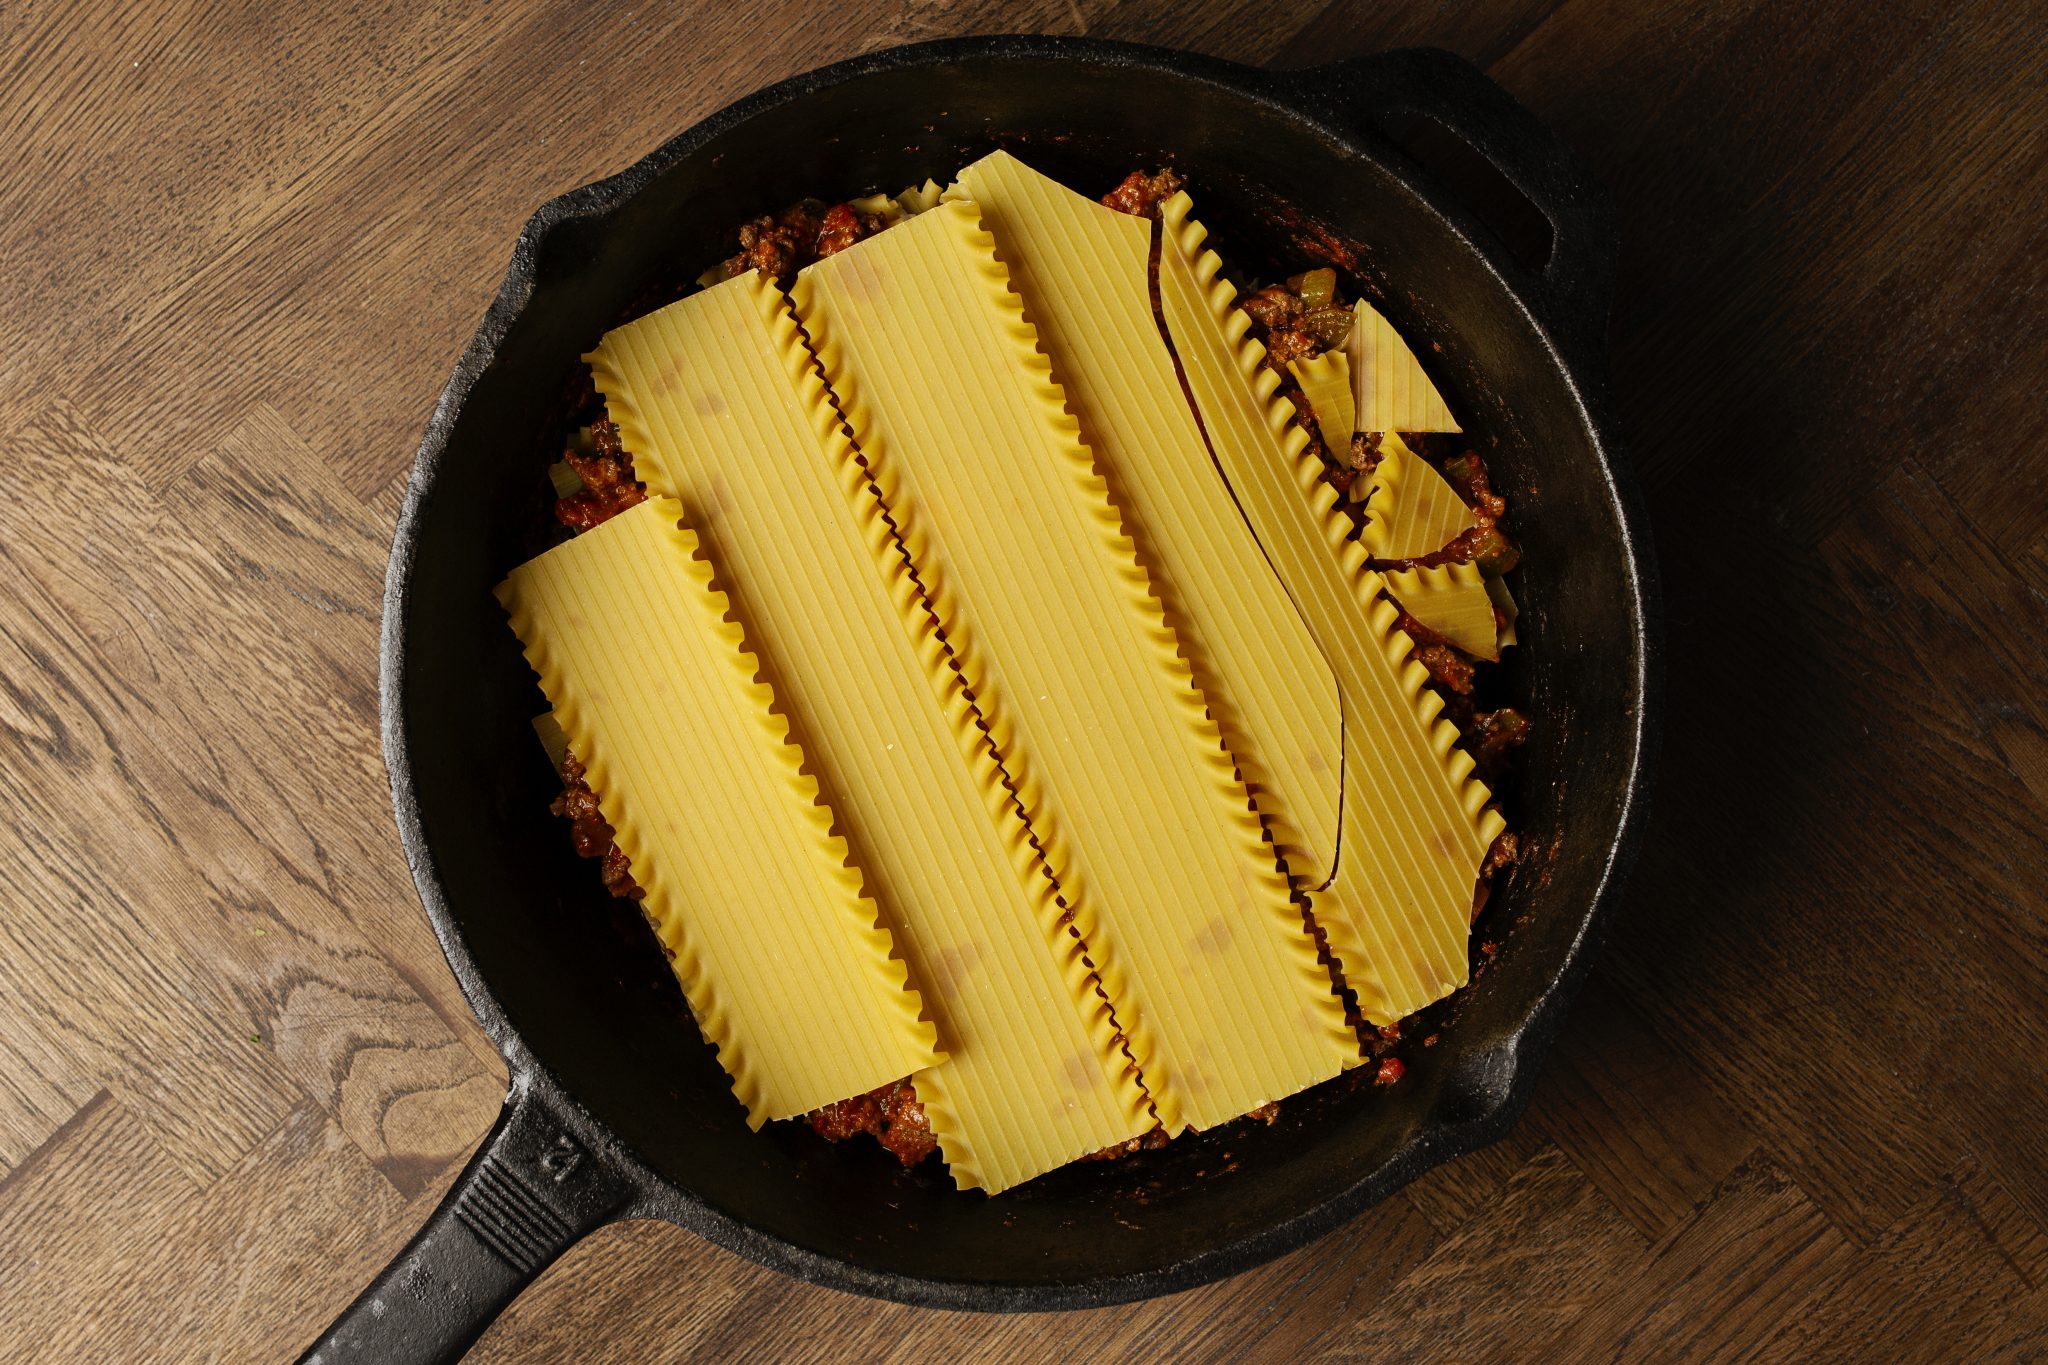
307 37 1657 1361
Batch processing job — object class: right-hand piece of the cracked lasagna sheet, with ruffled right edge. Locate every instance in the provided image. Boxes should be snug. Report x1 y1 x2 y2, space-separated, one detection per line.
1159 194 1501 1023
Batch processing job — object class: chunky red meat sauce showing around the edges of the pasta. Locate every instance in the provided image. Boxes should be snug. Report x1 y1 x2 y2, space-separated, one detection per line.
551 168 1528 1166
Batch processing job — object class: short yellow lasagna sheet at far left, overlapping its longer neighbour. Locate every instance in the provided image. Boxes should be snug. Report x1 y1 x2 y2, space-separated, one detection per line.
498 497 938 1128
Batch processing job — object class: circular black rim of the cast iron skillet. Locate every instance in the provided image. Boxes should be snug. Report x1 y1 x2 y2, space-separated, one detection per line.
379 35 1663 1310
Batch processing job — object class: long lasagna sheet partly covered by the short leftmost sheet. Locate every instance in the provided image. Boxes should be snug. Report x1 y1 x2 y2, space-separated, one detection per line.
590 272 1151 1193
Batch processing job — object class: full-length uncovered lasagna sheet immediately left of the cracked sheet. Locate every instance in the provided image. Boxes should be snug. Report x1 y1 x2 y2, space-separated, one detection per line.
795 201 1358 1132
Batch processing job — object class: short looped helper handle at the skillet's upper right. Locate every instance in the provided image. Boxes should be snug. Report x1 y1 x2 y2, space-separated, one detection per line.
1296 47 1620 372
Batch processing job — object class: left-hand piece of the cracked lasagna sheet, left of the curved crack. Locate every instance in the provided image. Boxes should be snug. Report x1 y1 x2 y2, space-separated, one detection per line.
954 151 1350 886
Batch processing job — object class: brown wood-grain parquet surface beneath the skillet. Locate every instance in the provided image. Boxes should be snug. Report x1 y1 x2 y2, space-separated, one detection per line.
0 0 2048 1361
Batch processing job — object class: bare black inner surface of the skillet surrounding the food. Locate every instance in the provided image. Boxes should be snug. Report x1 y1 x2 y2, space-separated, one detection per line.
401 50 1640 1287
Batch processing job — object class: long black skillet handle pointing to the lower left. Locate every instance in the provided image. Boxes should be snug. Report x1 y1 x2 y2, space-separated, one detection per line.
299 1074 631 1365
